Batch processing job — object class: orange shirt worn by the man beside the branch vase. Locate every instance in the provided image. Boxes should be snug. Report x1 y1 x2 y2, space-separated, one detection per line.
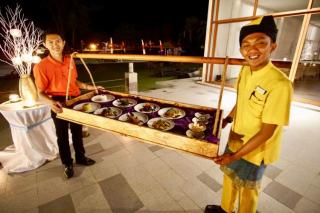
33 55 80 96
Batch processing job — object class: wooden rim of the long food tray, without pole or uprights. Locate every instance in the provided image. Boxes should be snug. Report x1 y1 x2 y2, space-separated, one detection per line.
58 91 223 158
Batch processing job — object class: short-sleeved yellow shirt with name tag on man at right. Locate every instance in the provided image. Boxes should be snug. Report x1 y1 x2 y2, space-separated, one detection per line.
228 62 293 165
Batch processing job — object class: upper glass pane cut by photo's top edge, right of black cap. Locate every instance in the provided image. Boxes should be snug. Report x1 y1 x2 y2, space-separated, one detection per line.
257 0 309 15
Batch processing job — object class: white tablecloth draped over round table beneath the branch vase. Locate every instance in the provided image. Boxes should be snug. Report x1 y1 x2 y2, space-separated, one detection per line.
0 102 59 172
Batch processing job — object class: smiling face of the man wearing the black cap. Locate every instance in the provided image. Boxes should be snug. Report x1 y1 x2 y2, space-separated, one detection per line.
240 33 277 71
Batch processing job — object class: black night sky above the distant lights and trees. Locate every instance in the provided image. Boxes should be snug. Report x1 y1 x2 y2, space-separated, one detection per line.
0 0 208 50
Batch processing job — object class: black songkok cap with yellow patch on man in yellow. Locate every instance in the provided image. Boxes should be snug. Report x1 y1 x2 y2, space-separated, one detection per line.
239 16 278 46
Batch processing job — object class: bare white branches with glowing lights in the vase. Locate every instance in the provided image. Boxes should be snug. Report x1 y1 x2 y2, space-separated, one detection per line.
0 5 43 76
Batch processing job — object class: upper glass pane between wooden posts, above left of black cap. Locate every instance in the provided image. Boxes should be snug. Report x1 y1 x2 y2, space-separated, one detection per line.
218 0 254 20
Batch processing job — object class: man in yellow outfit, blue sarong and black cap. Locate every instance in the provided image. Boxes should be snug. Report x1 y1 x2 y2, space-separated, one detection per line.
205 16 293 213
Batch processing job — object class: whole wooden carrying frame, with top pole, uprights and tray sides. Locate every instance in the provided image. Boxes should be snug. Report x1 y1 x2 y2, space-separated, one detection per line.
58 53 230 158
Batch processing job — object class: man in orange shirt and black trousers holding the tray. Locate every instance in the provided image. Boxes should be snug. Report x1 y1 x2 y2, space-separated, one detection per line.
33 33 104 178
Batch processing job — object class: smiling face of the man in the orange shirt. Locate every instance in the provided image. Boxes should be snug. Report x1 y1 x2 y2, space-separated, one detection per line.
44 34 65 57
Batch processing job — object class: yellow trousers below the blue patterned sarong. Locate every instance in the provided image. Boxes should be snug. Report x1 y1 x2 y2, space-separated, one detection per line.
221 175 259 213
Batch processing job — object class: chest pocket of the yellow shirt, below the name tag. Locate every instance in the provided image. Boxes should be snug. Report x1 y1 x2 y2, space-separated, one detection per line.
249 91 267 118
